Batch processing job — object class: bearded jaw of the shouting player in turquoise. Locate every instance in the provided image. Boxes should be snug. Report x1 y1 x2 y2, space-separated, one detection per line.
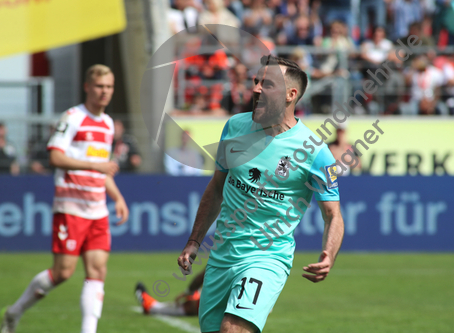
252 96 285 128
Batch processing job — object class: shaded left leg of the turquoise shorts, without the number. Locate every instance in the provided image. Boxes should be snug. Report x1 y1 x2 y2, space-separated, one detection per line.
199 265 234 333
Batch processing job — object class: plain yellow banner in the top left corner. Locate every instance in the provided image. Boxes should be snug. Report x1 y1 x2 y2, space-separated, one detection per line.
0 0 126 56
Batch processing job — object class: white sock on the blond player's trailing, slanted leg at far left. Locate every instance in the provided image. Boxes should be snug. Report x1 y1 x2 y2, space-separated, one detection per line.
8 269 54 317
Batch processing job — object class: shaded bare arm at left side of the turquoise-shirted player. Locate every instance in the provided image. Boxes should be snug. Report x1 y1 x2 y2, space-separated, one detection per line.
178 170 227 270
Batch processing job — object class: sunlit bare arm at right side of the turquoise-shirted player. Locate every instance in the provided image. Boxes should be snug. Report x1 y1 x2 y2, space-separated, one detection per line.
303 201 344 282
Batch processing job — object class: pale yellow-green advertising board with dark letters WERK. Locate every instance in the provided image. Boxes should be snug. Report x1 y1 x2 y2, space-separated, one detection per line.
166 117 454 176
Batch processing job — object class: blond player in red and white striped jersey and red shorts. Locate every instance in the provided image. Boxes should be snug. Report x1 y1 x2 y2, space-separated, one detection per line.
0 65 129 333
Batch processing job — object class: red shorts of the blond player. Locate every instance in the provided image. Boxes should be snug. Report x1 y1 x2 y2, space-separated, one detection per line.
52 213 111 256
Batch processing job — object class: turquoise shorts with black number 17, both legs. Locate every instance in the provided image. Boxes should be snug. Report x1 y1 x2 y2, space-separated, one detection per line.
199 261 288 332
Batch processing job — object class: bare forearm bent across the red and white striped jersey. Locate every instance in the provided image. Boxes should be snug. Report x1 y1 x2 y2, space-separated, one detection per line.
49 149 118 176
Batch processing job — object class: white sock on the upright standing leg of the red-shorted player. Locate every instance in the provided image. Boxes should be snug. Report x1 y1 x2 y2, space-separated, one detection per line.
80 279 104 333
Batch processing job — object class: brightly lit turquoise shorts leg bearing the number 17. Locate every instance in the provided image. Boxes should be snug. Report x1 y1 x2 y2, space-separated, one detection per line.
226 262 287 332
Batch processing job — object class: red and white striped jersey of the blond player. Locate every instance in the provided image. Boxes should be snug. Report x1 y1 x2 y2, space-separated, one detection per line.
47 104 114 220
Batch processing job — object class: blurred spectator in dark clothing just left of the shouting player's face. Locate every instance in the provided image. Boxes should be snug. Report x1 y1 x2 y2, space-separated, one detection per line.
222 63 253 114
